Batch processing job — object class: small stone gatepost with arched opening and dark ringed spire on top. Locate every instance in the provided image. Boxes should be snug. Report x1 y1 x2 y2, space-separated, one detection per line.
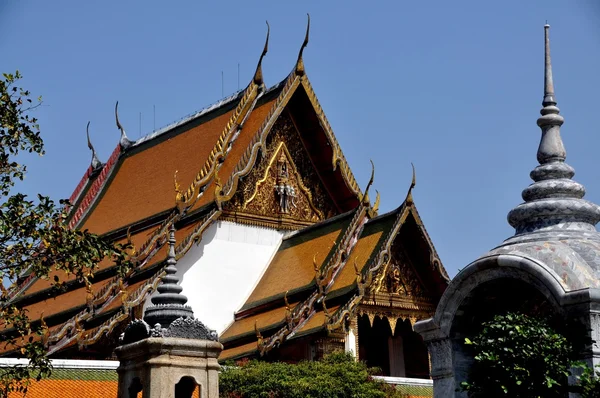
115 224 223 398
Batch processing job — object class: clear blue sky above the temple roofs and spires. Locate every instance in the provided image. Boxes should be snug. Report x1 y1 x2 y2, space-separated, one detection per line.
0 0 600 276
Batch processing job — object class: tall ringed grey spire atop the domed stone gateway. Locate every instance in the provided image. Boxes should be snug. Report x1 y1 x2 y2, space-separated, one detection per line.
508 24 600 235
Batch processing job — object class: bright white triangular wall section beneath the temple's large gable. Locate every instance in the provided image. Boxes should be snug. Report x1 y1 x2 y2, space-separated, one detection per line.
145 221 284 333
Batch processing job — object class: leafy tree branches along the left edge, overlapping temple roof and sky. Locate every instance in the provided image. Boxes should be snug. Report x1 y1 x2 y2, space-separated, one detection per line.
0 71 130 395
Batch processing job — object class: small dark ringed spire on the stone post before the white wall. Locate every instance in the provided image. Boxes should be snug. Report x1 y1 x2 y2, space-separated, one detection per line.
144 225 194 327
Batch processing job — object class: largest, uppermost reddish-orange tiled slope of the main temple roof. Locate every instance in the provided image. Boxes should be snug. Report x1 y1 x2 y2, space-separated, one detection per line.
81 110 233 233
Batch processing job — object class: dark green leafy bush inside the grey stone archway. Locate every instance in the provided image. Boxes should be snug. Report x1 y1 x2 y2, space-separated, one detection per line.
461 313 571 398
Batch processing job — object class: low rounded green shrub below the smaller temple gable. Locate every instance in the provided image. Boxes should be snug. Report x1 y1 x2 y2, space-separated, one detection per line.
219 352 402 398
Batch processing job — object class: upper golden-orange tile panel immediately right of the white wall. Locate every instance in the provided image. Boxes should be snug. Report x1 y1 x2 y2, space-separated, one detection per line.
243 220 345 308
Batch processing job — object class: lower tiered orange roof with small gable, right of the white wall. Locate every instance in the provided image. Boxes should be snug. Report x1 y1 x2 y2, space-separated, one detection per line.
220 186 448 360
